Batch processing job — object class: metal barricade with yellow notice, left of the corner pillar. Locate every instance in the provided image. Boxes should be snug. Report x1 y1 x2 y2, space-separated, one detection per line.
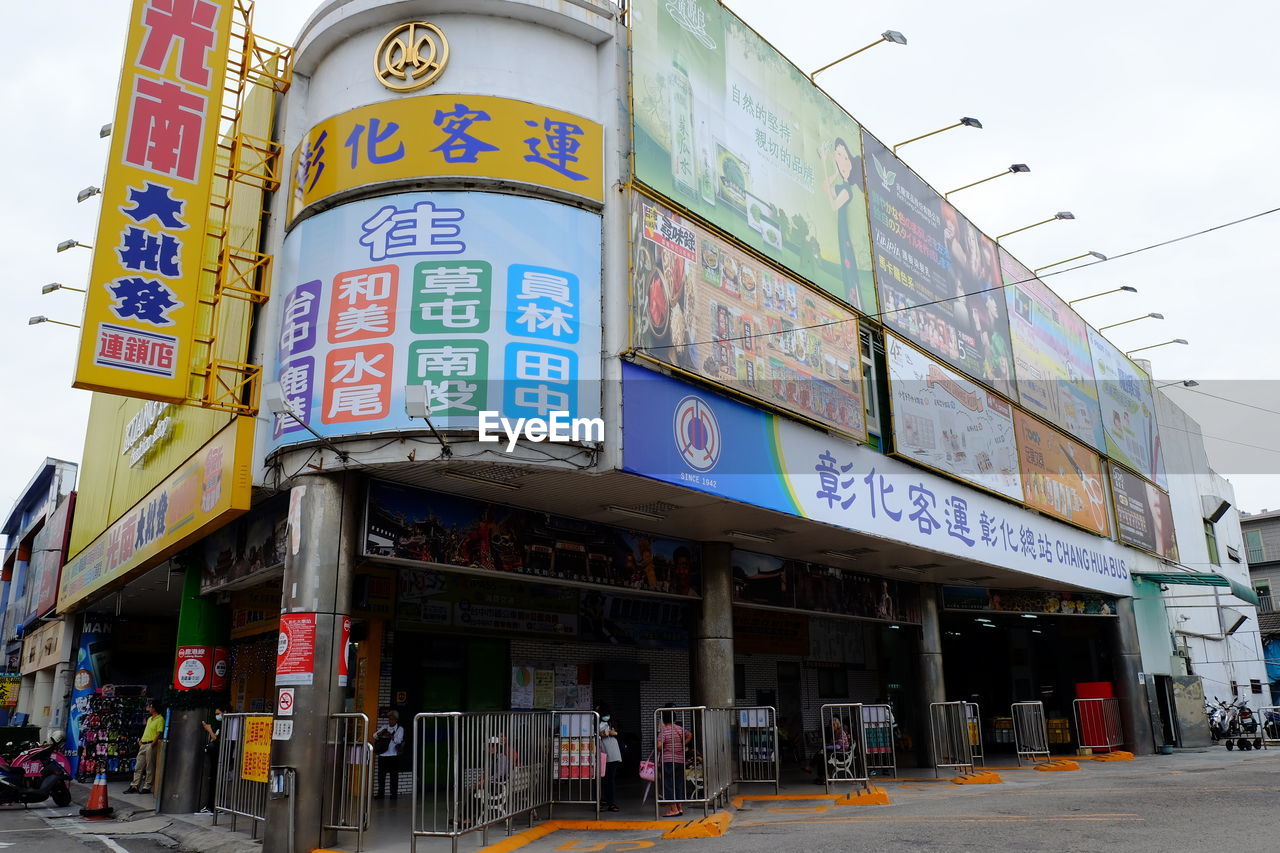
214 713 273 838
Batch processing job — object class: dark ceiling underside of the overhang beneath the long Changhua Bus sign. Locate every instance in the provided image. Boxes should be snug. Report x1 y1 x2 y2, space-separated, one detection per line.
366 461 1085 589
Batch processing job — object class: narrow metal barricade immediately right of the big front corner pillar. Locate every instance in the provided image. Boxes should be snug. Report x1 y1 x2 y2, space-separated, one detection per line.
324 713 373 853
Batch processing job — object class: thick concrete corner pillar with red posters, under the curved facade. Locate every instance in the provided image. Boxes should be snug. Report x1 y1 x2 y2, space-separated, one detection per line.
262 474 365 853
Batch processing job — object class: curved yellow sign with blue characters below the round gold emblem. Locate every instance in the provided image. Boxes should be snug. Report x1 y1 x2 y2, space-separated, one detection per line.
289 95 604 219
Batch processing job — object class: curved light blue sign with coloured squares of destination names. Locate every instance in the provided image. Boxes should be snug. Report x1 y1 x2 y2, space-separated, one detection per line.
270 192 600 447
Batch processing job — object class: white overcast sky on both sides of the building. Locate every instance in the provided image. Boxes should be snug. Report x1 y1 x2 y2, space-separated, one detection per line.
0 0 1280 511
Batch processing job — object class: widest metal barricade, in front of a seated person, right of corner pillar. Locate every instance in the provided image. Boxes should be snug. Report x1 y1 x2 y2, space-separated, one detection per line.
410 711 553 853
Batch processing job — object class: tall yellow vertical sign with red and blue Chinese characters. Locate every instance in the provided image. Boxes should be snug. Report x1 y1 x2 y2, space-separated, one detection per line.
74 0 233 402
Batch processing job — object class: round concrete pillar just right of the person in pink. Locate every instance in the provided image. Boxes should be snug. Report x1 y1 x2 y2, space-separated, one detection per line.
694 542 735 708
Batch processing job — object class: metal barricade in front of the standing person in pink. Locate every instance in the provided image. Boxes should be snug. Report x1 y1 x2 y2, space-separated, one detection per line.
653 706 736 816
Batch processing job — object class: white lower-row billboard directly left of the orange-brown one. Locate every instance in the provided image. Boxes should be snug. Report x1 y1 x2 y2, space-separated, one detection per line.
884 334 1023 501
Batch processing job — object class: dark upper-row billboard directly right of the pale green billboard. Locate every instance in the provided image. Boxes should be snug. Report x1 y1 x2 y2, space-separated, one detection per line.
863 133 1018 400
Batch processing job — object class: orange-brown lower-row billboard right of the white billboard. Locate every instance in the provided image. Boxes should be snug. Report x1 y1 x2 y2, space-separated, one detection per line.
1014 409 1111 537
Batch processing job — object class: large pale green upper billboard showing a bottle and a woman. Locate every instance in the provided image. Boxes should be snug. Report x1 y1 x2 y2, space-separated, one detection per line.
631 0 876 314
